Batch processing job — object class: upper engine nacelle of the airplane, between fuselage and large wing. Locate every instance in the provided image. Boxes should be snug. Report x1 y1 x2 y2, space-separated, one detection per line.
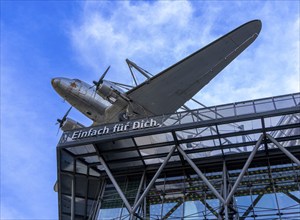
97 80 125 103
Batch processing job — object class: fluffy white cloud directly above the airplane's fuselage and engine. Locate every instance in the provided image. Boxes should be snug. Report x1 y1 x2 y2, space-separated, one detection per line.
71 1 214 80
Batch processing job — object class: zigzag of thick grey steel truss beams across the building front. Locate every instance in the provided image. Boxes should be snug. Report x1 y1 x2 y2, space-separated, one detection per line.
94 134 300 219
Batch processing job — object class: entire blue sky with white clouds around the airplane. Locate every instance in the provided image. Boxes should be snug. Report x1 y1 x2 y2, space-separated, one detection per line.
0 1 300 219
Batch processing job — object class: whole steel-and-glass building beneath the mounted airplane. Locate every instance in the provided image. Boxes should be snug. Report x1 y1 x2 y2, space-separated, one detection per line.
57 93 300 219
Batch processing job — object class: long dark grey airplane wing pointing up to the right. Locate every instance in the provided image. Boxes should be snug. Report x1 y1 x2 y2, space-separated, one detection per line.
127 20 261 115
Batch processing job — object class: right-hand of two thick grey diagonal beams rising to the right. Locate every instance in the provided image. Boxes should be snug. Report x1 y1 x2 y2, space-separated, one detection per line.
225 134 264 205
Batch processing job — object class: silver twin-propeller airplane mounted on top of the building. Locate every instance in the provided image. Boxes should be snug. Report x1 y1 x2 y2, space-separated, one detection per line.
51 20 262 131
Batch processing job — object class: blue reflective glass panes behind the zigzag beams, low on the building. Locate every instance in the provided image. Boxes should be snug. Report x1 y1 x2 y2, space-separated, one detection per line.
98 161 300 220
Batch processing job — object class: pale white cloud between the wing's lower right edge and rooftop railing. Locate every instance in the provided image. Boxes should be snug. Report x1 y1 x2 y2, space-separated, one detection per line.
193 2 300 105
